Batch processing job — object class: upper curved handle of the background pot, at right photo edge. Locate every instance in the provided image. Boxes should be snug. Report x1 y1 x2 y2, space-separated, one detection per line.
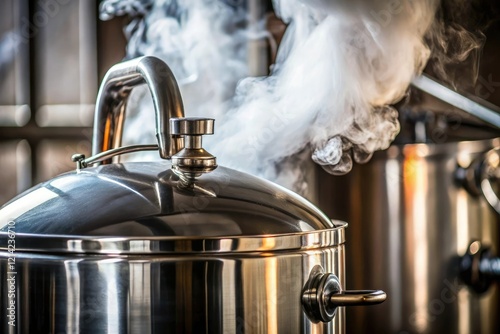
479 147 500 214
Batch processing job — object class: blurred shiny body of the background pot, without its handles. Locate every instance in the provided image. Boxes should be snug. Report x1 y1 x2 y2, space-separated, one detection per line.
318 138 500 333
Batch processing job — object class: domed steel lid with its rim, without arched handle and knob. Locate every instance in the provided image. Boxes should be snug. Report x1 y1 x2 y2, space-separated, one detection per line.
0 161 344 253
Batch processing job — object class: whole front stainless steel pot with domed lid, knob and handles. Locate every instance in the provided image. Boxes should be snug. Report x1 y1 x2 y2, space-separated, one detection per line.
0 57 386 334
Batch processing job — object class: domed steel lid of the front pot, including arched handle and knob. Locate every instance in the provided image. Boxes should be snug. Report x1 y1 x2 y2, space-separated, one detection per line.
0 57 345 254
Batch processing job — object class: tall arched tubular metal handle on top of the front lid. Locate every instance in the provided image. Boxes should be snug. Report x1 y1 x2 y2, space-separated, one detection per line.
92 56 184 163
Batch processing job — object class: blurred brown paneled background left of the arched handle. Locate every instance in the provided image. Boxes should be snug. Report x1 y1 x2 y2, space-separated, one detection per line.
0 0 125 204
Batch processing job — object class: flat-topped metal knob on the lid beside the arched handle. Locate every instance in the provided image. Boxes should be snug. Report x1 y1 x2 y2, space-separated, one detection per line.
170 117 217 179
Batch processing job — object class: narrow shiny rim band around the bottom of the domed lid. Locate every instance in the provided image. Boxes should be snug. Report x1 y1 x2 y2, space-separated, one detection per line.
0 221 347 255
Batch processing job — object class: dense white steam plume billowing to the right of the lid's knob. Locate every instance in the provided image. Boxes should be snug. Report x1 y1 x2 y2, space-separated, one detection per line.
214 0 437 186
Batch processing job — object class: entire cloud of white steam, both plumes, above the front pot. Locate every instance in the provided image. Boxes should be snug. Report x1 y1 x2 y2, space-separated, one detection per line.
103 0 438 190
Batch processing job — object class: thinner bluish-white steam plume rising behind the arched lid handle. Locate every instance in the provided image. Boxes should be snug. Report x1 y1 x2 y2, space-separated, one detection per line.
100 0 252 147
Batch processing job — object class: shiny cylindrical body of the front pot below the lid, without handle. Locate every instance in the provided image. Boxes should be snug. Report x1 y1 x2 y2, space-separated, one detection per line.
0 244 345 334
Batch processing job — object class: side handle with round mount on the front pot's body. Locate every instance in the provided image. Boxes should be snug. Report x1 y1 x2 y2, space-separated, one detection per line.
302 266 387 323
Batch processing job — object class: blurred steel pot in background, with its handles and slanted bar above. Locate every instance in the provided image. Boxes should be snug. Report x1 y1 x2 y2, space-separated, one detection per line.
318 79 500 334
